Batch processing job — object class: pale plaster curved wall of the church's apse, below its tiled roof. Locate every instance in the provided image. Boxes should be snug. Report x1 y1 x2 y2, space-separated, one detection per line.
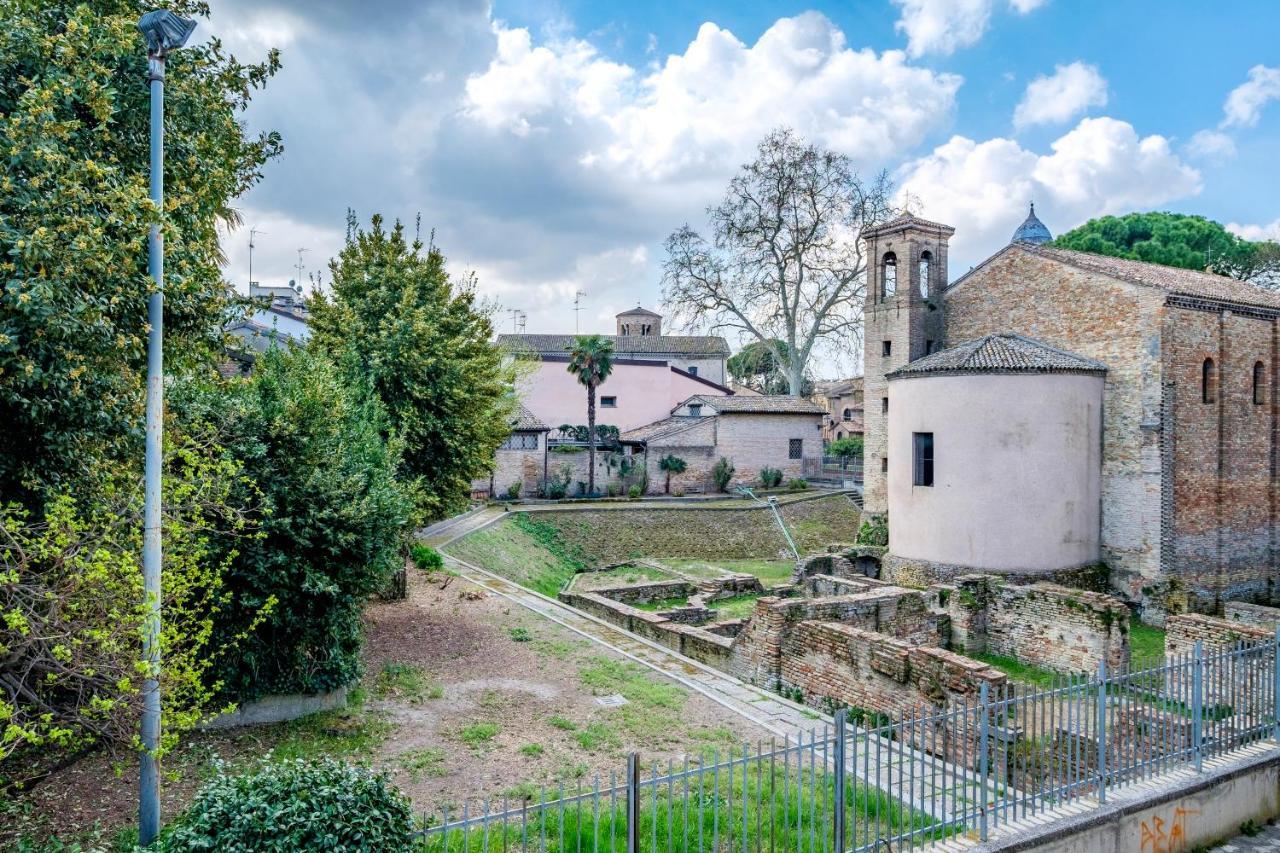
888 374 1102 571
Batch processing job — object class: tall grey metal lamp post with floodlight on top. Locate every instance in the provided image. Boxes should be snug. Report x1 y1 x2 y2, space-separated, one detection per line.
138 9 196 847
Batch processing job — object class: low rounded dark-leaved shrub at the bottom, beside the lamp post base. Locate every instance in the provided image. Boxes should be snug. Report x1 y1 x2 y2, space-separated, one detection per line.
160 758 413 853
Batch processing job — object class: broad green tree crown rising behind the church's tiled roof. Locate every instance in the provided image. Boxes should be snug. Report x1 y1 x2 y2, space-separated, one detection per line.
1052 213 1280 289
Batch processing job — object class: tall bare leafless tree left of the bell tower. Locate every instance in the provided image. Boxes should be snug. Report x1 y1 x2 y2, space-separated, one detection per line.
663 128 892 396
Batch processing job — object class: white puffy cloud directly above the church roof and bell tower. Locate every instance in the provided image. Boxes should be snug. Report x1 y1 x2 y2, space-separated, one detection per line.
900 118 1201 263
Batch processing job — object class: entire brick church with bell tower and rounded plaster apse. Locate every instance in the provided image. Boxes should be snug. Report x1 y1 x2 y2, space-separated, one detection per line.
864 207 1280 621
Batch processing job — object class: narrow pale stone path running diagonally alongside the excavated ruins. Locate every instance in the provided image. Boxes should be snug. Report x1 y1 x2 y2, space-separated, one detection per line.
421 507 993 818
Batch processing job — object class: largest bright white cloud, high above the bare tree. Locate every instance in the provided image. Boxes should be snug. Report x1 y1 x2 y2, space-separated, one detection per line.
465 13 961 181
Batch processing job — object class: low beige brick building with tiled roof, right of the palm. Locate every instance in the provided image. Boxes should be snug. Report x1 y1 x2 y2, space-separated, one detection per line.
622 394 826 494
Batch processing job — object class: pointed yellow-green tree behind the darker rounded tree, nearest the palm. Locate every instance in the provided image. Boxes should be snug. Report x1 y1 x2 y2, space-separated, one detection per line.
311 215 516 521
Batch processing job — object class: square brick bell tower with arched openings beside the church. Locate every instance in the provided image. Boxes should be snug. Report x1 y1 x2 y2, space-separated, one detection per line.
863 213 955 515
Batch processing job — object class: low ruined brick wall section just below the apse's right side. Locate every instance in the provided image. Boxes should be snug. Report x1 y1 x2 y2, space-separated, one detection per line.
947 575 1129 672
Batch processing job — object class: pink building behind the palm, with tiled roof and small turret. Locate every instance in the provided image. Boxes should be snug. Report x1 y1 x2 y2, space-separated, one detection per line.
498 307 733 432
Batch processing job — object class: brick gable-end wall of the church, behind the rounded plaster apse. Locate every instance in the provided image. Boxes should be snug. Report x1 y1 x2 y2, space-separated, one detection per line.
945 247 1165 601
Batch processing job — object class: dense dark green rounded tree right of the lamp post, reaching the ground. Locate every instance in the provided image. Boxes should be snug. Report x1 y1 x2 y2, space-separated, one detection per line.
170 347 412 701
